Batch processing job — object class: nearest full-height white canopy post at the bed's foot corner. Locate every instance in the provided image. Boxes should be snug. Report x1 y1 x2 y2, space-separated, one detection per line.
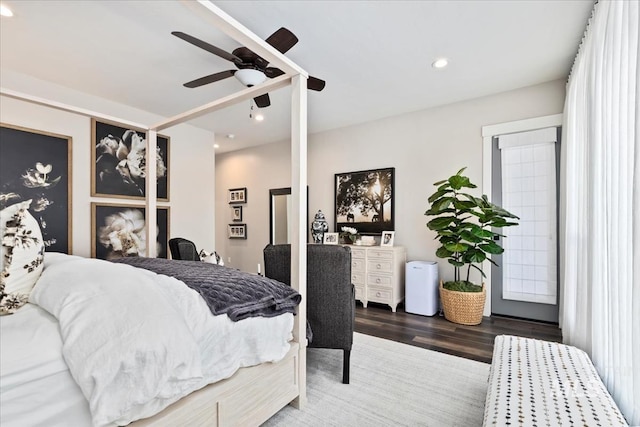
291 74 307 409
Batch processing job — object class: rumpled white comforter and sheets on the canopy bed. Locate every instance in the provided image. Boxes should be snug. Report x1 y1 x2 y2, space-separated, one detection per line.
0 253 293 426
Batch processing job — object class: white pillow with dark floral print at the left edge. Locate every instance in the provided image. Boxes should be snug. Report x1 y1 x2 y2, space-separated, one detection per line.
0 200 44 314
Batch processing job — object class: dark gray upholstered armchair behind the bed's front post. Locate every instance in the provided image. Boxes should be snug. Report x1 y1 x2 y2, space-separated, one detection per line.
264 244 355 384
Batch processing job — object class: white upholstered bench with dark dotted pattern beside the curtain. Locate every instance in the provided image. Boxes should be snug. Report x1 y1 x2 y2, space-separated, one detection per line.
484 335 627 427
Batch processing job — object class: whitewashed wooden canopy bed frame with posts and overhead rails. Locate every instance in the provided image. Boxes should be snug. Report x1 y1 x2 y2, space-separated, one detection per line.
0 0 309 427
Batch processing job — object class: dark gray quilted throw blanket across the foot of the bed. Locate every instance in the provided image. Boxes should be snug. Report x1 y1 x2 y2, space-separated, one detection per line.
111 257 302 322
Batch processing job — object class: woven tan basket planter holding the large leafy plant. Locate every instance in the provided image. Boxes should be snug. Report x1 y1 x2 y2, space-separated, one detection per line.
440 281 487 325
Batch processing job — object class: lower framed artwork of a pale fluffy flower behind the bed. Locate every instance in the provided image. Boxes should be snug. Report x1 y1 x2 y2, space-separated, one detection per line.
91 202 169 259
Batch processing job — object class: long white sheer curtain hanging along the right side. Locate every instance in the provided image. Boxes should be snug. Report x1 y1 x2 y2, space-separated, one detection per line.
561 0 640 425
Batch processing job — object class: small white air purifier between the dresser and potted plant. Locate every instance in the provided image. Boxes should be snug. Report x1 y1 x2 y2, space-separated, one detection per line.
404 261 438 316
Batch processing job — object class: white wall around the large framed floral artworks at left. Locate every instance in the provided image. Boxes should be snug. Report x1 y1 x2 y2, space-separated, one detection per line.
0 70 215 256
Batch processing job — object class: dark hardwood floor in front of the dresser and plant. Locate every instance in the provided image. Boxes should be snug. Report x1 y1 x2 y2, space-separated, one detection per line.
355 302 562 363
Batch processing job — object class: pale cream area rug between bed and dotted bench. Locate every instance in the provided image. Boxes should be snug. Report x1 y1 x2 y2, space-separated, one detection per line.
263 333 489 427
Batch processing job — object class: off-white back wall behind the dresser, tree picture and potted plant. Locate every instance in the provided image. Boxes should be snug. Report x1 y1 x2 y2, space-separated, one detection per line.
216 80 565 280
